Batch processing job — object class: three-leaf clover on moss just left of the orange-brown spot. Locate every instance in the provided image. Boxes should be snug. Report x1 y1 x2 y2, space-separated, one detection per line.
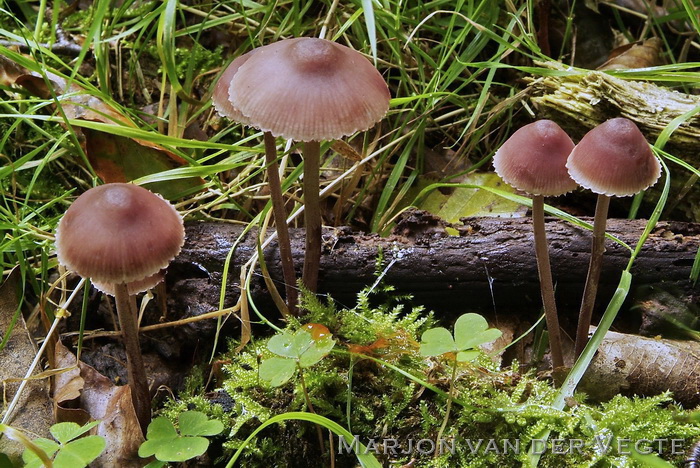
260 325 335 387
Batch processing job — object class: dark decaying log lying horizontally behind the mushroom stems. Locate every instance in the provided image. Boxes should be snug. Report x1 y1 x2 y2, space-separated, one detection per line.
167 212 700 326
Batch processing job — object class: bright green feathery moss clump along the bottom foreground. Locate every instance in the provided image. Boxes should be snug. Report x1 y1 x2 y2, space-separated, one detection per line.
159 266 700 467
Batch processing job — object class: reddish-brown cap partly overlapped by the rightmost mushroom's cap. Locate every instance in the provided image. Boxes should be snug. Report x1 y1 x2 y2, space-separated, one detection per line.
493 120 576 196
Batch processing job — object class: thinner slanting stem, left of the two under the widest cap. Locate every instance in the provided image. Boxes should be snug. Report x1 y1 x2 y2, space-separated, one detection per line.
265 132 298 315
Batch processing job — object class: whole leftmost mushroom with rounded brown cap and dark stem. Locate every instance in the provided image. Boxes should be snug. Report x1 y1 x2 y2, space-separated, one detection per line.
56 183 185 434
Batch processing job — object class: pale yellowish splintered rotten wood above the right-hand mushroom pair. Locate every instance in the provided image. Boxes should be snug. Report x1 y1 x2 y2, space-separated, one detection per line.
530 62 700 157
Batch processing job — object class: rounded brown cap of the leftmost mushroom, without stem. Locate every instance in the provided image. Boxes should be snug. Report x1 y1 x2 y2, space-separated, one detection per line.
56 184 185 284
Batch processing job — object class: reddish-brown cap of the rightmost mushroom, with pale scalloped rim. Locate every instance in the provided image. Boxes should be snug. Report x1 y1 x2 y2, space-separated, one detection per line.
566 117 661 197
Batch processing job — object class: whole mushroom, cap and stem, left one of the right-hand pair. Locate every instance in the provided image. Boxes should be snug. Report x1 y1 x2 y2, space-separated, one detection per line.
493 120 576 369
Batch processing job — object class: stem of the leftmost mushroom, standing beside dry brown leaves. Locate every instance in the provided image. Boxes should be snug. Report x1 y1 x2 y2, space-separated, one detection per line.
114 283 151 434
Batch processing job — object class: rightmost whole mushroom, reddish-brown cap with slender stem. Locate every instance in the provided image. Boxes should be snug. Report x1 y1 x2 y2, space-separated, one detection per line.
566 117 661 356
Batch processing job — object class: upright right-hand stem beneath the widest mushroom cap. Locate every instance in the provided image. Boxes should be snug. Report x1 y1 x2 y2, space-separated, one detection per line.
302 141 321 292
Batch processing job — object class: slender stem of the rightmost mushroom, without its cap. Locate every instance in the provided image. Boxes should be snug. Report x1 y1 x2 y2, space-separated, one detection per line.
575 194 610 357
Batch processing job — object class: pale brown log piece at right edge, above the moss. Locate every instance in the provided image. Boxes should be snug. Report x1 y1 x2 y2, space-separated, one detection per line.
580 332 700 408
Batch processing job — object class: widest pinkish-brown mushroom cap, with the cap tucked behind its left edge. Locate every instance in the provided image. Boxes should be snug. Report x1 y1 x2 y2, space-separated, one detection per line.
217 37 390 141
